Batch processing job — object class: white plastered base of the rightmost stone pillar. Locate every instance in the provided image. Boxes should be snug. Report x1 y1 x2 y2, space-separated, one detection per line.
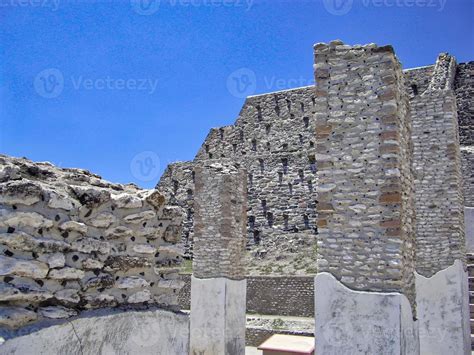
415 260 471 355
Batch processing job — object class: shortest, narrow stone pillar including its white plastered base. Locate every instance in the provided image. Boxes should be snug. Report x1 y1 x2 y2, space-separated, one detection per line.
190 163 247 355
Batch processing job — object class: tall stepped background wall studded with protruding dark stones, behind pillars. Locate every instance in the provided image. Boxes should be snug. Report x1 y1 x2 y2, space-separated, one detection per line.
157 58 474 275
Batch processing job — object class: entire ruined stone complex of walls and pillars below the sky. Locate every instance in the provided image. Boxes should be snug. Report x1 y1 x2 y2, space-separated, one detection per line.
0 41 474 355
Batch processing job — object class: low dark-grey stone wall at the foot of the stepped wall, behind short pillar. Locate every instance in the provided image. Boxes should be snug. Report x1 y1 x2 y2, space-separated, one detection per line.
178 275 314 317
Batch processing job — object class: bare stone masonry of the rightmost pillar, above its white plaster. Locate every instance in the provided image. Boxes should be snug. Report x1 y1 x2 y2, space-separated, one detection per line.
410 54 466 277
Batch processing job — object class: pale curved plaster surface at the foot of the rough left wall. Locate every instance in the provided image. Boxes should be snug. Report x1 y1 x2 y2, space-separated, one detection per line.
1 310 189 355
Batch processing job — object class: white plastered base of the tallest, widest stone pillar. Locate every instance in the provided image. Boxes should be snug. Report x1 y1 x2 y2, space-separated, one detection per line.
314 272 419 355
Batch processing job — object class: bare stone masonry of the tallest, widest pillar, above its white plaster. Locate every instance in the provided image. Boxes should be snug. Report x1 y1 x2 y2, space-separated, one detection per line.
315 41 415 305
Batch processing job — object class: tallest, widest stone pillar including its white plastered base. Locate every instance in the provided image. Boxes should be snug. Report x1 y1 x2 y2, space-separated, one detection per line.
315 41 419 354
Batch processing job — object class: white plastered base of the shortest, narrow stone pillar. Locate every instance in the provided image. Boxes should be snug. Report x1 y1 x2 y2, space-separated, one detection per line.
190 276 247 355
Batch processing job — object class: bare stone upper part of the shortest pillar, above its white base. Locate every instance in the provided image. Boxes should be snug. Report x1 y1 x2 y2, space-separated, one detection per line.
193 163 247 280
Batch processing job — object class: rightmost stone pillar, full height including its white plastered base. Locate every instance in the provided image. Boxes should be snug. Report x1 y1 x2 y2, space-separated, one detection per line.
411 53 471 355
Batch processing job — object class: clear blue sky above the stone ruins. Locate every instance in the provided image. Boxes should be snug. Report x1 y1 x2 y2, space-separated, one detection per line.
0 0 474 187
